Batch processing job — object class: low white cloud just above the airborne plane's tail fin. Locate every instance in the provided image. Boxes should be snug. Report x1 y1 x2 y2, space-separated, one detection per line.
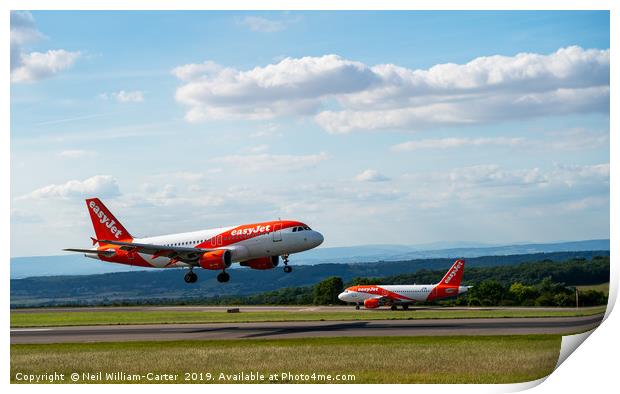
20 175 120 200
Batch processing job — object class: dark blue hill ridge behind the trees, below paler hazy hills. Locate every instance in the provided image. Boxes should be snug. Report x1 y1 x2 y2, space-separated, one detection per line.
11 251 609 307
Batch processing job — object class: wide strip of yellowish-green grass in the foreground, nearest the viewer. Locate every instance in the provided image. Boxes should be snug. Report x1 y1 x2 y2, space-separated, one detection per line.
10 335 561 383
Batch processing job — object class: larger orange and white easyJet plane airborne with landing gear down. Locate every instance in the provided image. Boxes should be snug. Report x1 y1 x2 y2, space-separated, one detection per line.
63 198 323 283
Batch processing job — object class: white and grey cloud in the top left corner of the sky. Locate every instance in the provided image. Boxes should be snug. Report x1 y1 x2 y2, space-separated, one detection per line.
11 11 80 83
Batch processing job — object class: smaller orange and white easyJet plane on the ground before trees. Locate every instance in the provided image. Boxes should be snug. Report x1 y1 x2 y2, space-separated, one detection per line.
338 259 471 311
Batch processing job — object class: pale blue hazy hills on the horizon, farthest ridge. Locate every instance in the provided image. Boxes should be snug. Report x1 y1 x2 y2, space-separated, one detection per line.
11 239 609 279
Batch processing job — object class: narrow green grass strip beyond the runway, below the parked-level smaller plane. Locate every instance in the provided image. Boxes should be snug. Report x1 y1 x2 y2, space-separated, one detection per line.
11 306 605 327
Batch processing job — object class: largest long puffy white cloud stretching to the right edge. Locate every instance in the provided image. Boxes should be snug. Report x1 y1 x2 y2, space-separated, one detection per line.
173 46 609 133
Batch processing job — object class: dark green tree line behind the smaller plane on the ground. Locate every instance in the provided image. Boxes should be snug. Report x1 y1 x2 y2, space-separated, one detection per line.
23 256 609 307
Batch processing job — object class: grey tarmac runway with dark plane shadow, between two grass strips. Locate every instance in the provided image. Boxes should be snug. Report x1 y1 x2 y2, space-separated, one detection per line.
11 314 603 344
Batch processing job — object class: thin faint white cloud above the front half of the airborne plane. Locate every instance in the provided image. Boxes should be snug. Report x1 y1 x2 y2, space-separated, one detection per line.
212 152 327 172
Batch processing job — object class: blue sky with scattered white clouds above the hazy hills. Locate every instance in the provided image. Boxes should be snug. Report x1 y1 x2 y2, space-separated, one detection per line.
11 11 610 256
